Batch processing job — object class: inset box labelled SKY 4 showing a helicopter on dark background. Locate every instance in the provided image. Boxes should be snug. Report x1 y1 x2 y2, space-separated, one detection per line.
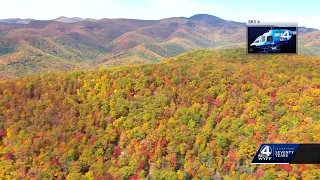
246 19 298 54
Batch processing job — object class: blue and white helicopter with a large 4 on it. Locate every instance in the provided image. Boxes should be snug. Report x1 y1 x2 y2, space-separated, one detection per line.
249 29 297 53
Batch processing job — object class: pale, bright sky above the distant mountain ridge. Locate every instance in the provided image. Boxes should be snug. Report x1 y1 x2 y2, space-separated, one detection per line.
0 0 320 29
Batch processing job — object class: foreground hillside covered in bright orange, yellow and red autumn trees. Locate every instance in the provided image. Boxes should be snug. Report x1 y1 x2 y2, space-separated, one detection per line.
0 49 320 180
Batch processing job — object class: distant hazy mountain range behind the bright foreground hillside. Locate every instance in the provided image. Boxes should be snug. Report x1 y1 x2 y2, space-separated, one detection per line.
0 14 320 76
